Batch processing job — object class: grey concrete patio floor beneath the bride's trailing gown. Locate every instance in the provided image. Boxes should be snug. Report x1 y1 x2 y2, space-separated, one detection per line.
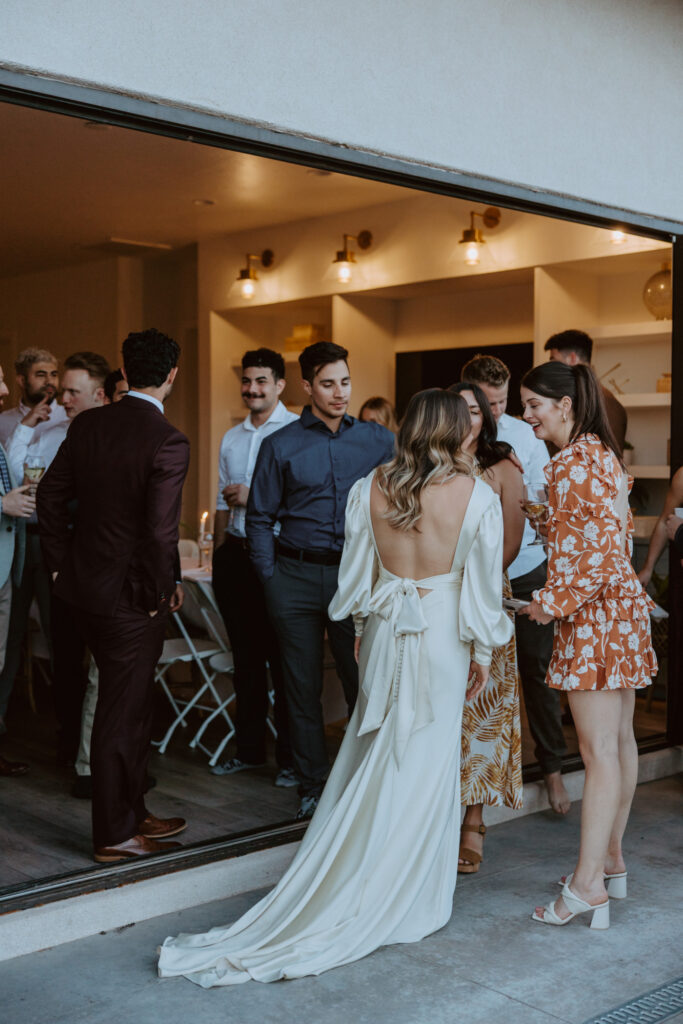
0 775 683 1024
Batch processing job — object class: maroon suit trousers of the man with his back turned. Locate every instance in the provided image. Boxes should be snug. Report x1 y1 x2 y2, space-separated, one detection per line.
80 592 168 847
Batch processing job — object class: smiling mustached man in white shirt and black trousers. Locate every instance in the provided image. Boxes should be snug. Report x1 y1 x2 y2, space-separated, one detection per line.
212 348 298 786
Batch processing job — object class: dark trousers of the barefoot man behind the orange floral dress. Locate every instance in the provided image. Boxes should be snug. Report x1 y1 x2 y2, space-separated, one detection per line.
510 561 566 774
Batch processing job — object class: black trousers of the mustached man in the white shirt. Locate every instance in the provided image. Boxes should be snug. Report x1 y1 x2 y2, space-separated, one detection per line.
212 537 292 768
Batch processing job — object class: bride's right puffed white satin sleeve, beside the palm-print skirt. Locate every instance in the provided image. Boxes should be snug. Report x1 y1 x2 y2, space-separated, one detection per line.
459 494 513 665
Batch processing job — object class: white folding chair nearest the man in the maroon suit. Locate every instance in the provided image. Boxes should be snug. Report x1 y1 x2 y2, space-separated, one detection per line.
154 588 234 756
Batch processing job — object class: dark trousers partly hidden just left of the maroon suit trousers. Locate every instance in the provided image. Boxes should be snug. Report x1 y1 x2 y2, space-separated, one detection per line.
50 594 88 761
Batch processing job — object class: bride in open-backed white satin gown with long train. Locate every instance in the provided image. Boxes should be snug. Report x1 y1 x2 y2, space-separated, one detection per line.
159 389 512 988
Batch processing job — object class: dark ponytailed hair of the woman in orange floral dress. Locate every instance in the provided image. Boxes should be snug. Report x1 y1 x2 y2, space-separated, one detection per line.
522 361 624 466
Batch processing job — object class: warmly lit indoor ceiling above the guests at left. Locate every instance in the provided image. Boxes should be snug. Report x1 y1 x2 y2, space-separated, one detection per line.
0 103 411 278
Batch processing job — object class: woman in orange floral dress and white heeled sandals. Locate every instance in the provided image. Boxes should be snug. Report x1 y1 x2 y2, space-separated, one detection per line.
521 362 656 928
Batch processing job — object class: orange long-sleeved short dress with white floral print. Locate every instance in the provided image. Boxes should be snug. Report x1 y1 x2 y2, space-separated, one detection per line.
533 434 657 690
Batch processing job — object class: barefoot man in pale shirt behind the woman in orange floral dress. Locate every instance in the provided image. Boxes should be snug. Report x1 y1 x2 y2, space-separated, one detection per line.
461 355 570 814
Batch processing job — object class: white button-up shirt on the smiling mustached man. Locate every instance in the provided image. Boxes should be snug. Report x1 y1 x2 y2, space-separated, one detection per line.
216 401 299 537
